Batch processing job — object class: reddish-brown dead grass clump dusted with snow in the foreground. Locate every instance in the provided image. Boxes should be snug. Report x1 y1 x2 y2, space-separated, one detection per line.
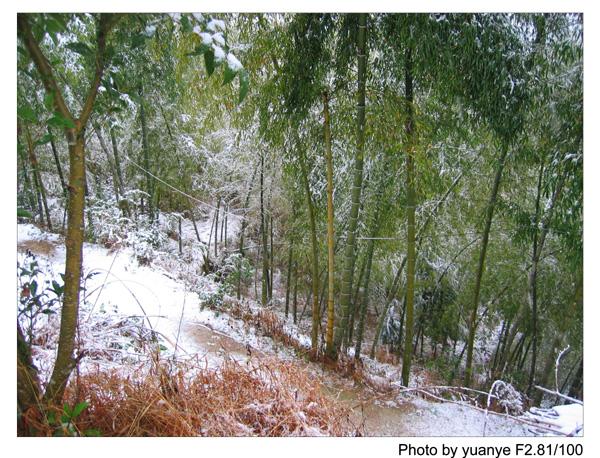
59 360 354 436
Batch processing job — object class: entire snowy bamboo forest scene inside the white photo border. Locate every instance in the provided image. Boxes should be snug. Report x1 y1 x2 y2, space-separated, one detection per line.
17 13 583 437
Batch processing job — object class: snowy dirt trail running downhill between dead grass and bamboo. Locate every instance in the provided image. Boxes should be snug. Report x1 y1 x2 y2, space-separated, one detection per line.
18 225 552 436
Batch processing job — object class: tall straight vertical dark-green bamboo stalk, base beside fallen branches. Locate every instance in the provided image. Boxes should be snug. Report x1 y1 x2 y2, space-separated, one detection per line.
402 43 416 386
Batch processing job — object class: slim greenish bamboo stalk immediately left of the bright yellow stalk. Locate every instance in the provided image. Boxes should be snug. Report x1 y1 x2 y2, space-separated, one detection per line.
300 147 320 357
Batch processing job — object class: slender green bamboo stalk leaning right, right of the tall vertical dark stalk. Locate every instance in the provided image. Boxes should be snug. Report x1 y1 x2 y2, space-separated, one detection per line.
465 144 508 386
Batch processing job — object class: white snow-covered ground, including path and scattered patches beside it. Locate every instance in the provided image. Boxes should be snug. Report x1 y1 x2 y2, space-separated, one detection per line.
18 224 582 436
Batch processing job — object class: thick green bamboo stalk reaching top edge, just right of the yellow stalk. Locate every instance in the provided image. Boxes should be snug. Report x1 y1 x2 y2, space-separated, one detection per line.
334 13 367 352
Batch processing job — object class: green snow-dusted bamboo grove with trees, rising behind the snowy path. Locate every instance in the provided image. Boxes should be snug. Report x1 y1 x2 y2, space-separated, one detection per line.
17 13 583 416
